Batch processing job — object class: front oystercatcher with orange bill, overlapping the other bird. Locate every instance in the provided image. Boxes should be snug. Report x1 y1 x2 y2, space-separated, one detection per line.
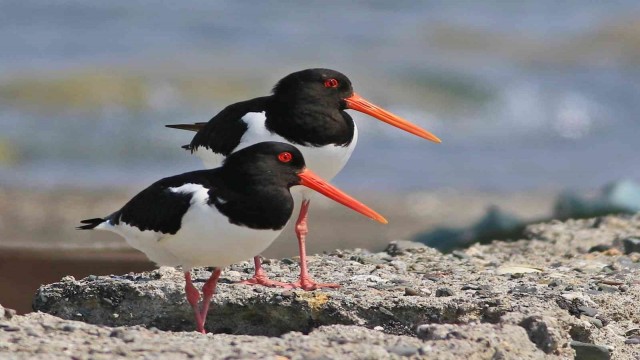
78 142 386 333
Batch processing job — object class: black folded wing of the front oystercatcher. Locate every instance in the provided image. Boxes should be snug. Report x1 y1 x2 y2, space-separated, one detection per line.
105 170 216 235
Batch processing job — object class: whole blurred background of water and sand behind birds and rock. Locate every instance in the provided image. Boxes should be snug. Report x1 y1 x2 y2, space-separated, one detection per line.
0 0 640 311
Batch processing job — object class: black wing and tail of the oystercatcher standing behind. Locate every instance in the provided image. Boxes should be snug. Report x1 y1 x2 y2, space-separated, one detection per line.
167 96 271 156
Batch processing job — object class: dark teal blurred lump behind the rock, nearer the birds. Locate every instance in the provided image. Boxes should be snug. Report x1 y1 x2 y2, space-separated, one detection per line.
414 206 527 252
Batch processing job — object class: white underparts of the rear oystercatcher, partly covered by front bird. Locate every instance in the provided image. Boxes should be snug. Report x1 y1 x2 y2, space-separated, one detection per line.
195 113 358 181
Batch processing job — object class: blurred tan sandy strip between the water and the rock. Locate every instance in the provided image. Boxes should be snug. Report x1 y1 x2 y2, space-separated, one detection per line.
0 189 555 313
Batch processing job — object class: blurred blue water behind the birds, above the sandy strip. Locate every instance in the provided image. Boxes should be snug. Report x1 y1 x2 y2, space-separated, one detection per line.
0 0 640 190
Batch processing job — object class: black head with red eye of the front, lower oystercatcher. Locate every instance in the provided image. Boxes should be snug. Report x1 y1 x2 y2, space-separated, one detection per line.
222 141 305 188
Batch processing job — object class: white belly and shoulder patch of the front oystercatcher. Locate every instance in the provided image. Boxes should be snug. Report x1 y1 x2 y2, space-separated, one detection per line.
97 184 282 269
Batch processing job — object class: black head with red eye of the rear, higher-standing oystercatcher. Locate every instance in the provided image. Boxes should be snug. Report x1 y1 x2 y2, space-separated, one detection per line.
273 69 353 110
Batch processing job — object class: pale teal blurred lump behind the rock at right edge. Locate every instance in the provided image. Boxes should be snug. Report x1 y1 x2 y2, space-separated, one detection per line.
553 180 640 220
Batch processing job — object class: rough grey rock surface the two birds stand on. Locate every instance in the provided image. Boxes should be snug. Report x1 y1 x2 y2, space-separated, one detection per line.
0 215 640 359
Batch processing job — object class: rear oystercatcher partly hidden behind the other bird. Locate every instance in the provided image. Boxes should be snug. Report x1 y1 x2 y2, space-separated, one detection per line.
167 69 440 290
